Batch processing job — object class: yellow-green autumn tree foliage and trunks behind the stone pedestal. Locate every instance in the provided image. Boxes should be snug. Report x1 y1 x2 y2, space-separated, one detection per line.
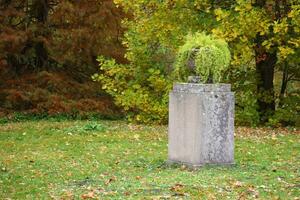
95 0 300 124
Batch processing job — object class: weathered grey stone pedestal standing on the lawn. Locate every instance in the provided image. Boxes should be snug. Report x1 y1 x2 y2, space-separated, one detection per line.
168 83 234 167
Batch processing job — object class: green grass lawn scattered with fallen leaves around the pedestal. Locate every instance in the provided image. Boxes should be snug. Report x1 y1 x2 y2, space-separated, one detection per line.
0 121 300 199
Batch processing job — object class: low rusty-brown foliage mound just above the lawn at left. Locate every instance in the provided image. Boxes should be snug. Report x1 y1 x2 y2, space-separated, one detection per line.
0 71 118 116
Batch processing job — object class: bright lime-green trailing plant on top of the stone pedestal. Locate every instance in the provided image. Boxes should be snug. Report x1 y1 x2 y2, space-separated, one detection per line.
175 33 230 83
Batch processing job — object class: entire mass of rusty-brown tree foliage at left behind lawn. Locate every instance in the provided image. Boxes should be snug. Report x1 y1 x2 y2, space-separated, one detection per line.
0 0 126 118
